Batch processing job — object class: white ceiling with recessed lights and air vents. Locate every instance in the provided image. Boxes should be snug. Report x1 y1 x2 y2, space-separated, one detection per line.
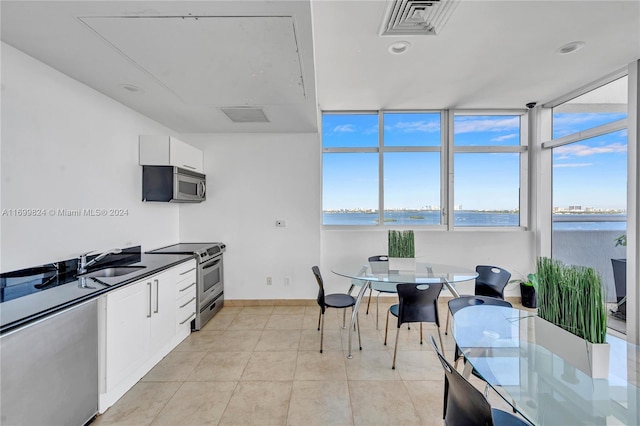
0 0 640 133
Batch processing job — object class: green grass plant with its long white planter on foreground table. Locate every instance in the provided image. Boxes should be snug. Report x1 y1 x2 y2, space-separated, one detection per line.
536 257 609 378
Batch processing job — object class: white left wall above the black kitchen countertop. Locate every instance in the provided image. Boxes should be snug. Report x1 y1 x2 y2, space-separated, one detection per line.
0 43 178 272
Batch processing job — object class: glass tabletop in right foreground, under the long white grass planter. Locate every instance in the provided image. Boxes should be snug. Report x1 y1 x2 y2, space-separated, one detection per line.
452 306 640 425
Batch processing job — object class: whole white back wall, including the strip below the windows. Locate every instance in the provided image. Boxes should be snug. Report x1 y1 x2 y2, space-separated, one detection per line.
180 134 535 299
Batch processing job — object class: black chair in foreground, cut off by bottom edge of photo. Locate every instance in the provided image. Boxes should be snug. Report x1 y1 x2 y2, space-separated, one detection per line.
429 336 529 426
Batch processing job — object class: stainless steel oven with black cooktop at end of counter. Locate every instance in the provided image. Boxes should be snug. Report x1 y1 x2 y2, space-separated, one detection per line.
147 243 226 330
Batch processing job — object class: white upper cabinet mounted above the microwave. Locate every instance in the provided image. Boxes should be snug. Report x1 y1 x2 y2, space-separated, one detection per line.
140 135 204 173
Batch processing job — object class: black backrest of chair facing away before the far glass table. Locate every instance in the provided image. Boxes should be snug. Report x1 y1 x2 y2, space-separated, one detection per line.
396 283 442 327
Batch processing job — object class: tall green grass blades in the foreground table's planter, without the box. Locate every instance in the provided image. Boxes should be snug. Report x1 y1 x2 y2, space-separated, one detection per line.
537 257 607 343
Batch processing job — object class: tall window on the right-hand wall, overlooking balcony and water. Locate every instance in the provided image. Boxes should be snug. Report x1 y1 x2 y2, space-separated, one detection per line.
543 76 627 311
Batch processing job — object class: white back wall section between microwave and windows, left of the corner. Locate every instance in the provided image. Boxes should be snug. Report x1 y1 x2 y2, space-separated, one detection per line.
180 133 321 299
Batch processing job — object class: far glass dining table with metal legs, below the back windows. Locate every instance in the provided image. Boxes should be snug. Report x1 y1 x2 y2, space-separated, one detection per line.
331 258 478 359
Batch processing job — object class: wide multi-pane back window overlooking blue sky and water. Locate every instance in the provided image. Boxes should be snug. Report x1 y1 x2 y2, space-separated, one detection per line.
322 111 526 228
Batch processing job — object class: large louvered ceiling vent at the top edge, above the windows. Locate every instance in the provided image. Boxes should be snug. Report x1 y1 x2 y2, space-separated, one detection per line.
380 0 460 35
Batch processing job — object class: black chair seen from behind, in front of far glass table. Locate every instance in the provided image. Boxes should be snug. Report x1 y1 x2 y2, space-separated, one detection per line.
384 283 442 370
